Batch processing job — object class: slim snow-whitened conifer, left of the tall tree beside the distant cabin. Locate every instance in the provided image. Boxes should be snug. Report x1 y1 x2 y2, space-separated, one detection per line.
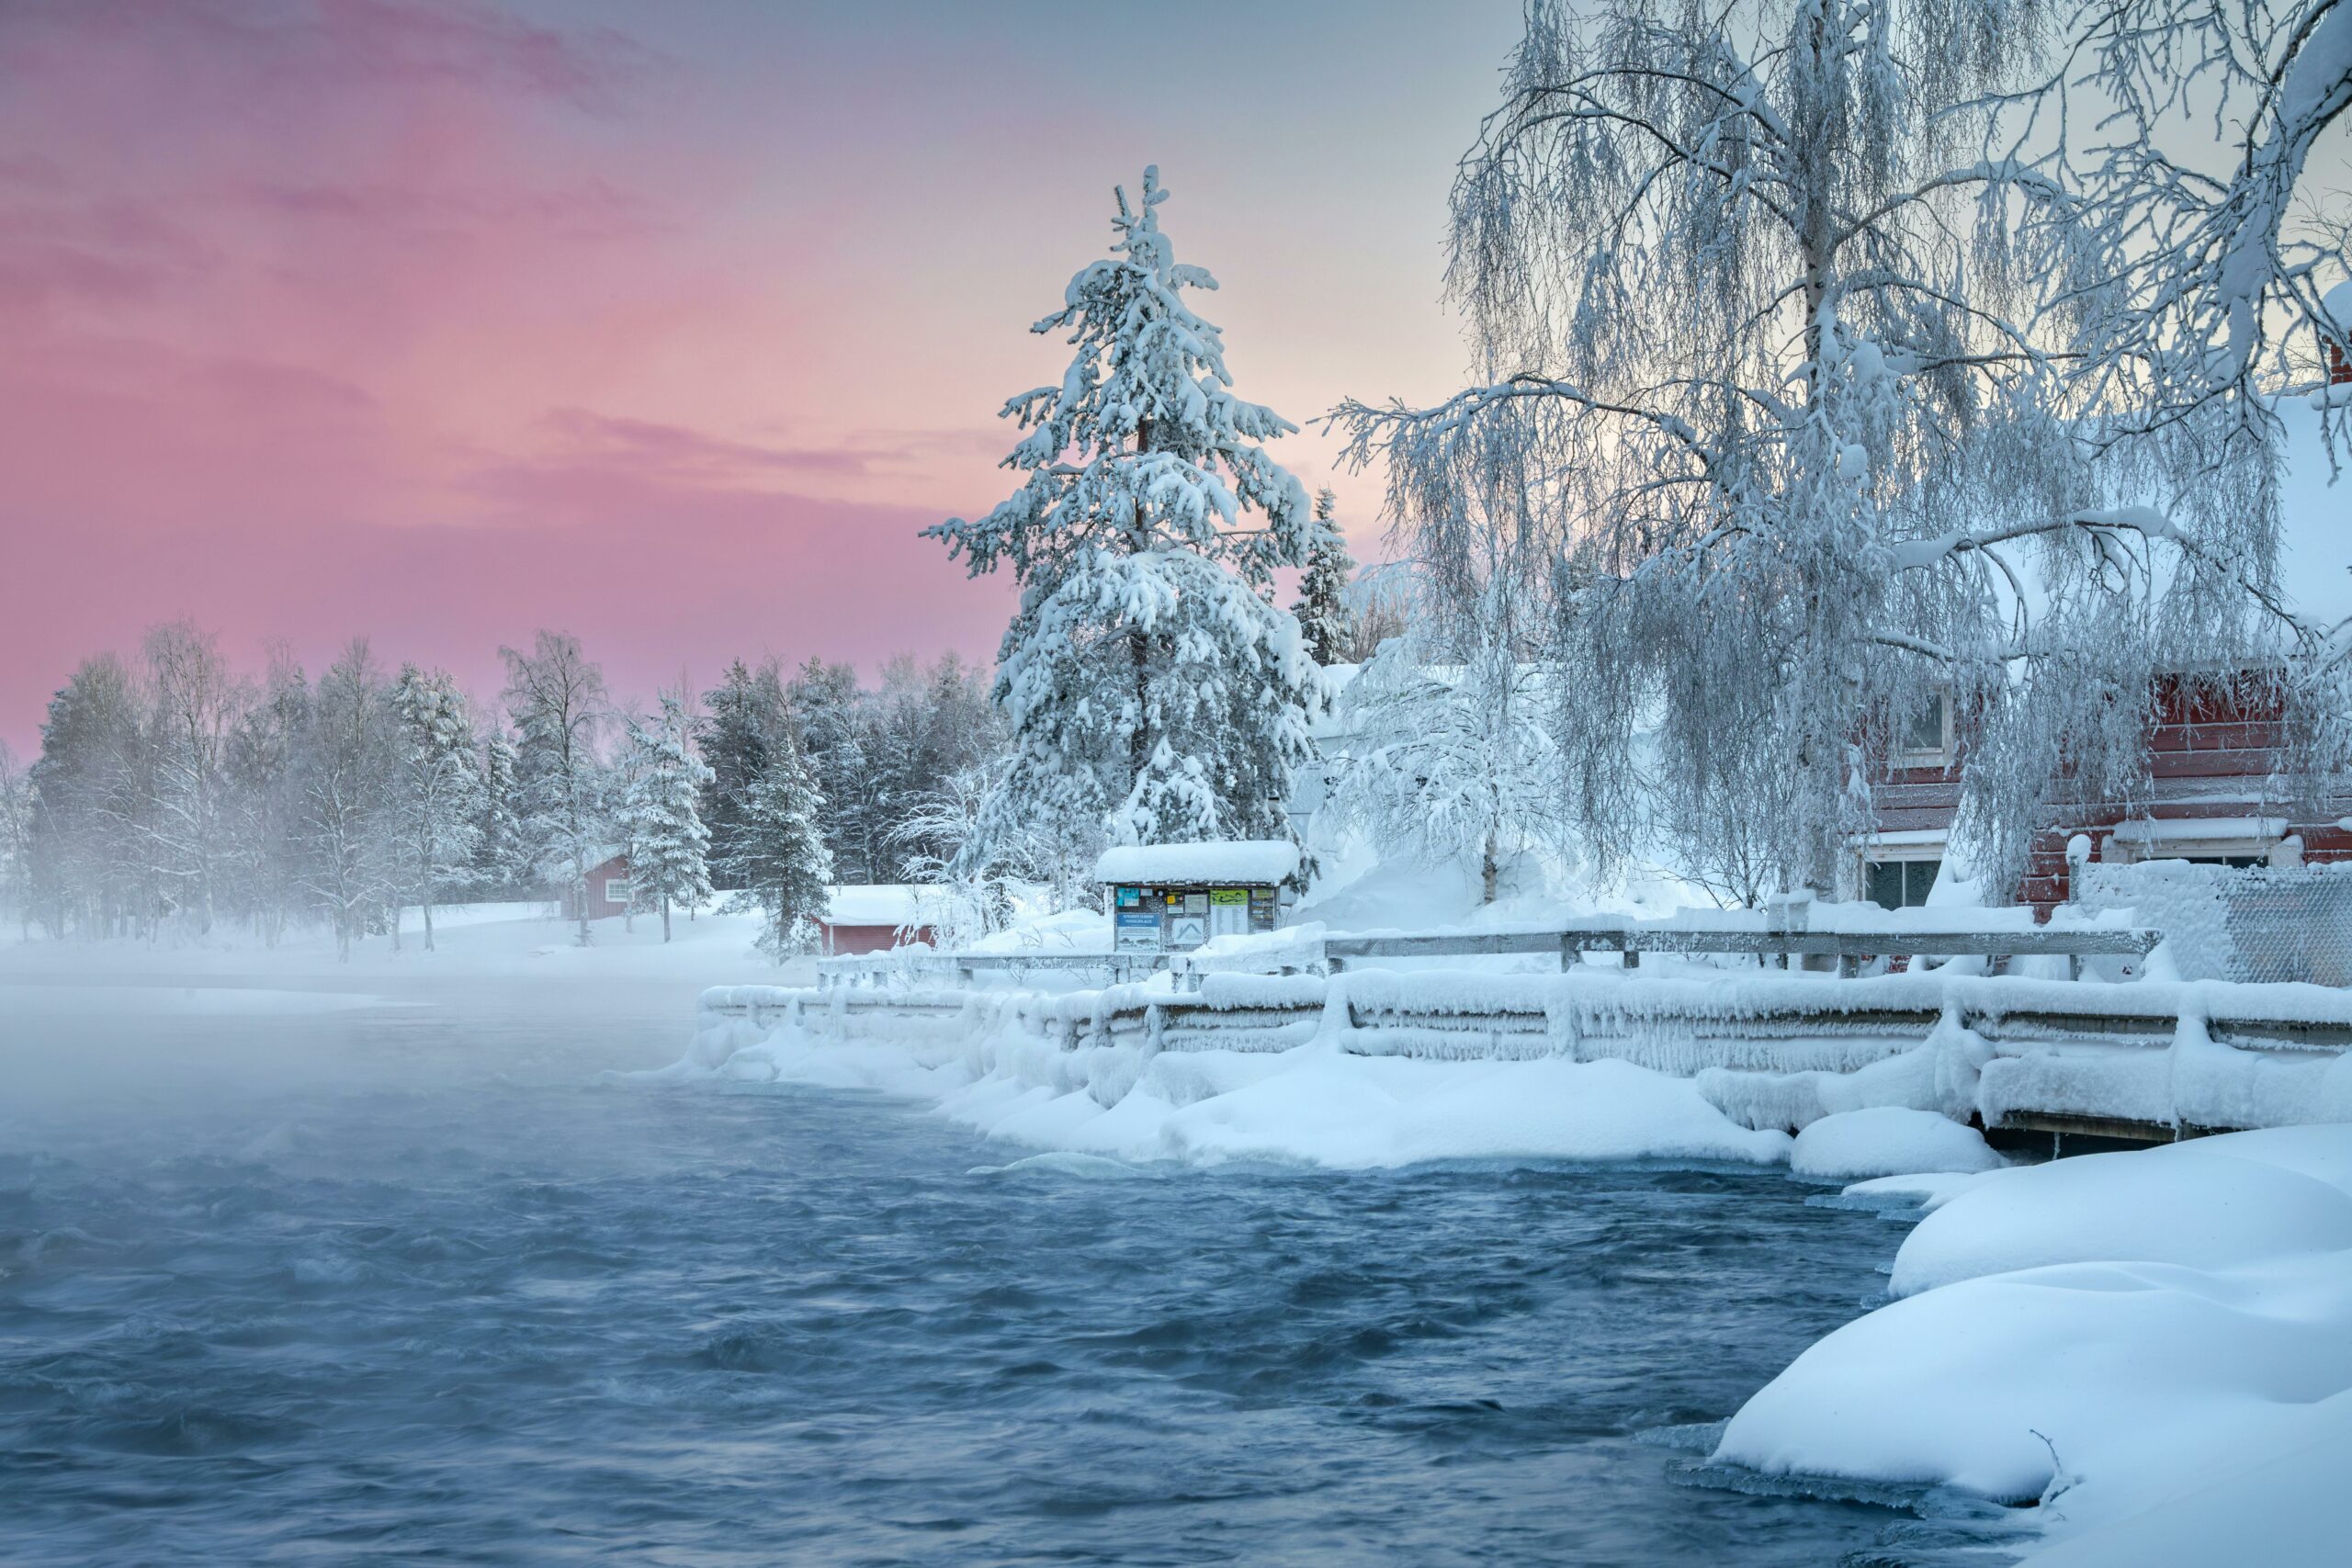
388 665 482 952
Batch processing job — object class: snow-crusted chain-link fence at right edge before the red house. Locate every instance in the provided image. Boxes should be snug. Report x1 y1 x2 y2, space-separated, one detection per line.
2075 861 2352 985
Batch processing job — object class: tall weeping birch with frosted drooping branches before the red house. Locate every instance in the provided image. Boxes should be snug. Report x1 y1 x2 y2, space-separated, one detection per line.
1340 0 2304 891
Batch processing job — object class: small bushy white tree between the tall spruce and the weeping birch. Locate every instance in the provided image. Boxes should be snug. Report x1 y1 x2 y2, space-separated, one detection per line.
1331 579 1564 903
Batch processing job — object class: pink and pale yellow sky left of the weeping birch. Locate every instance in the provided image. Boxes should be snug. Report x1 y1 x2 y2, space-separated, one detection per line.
0 0 1517 750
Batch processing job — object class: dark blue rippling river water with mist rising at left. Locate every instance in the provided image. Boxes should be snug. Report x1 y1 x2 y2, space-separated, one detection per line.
0 980 2022 1563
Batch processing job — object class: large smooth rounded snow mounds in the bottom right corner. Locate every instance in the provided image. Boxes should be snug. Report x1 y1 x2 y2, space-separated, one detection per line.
1714 1126 2352 1563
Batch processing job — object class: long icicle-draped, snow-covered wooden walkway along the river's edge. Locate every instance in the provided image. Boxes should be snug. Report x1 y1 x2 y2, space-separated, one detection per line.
689 968 2352 1140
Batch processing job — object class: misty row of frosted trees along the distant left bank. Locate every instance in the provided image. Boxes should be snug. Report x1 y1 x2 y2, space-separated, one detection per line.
0 621 1004 945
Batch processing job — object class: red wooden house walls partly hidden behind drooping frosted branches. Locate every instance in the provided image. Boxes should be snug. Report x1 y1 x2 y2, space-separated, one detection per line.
1860 677 2352 915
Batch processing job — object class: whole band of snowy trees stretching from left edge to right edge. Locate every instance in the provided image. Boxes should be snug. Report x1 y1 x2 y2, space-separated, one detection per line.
0 0 2352 942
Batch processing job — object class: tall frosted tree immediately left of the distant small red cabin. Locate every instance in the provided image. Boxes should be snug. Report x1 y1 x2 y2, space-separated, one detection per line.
499 632 609 947
